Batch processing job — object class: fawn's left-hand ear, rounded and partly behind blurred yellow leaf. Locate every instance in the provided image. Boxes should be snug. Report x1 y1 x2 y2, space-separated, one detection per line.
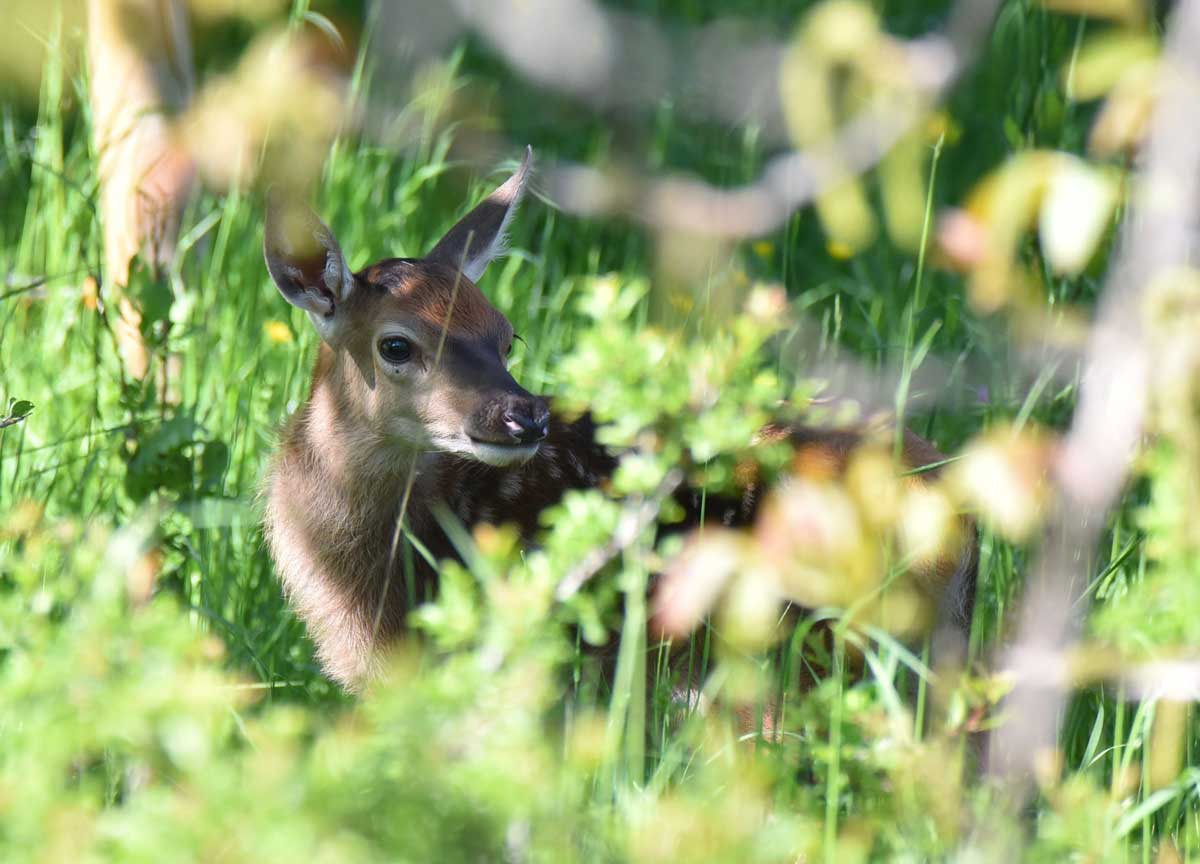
263 190 354 342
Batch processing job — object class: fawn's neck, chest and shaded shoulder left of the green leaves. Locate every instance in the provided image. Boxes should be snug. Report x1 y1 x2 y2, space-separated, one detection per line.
266 374 616 689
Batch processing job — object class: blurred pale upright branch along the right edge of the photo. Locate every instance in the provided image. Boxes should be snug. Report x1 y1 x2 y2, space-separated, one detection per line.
986 0 1200 808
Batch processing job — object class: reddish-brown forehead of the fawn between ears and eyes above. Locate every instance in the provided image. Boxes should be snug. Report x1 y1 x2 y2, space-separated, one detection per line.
358 258 512 344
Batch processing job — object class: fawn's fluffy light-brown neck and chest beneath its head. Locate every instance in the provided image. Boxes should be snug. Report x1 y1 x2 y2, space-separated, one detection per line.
265 348 451 685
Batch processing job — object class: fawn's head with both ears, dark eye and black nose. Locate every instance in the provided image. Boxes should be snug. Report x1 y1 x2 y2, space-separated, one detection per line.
264 148 550 466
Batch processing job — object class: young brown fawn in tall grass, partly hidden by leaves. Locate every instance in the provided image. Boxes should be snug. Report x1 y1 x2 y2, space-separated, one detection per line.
264 149 974 689
